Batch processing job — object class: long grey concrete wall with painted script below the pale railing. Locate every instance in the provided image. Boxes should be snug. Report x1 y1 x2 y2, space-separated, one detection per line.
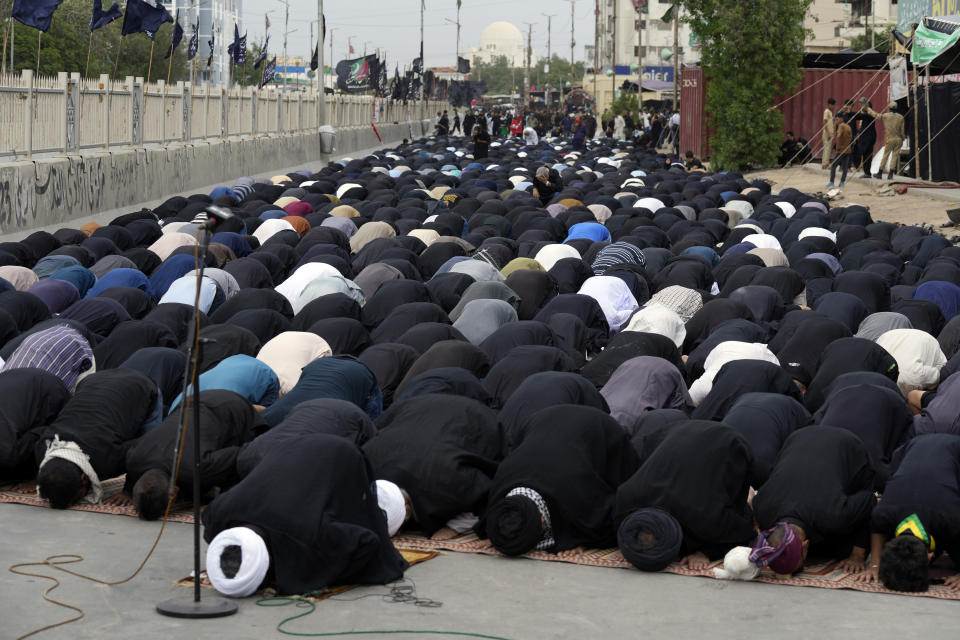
0 120 432 234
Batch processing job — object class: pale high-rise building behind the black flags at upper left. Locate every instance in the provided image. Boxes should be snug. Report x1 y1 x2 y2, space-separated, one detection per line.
161 0 242 84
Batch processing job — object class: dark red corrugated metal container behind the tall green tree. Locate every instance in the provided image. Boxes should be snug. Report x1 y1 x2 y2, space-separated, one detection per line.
680 67 890 158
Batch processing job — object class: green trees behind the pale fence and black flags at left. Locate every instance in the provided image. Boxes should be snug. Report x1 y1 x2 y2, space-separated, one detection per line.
0 0 190 82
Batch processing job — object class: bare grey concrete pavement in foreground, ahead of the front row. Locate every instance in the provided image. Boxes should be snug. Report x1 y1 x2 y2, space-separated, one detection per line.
0 504 960 640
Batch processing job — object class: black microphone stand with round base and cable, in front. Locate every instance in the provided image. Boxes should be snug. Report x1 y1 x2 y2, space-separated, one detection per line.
157 217 237 618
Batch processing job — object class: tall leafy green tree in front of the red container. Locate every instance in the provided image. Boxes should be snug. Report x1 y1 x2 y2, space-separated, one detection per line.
684 0 811 170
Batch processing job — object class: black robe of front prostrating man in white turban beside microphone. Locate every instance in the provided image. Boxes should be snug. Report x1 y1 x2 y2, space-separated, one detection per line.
203 434 408 595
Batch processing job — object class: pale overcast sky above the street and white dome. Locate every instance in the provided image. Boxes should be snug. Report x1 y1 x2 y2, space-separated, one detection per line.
236 0 594 68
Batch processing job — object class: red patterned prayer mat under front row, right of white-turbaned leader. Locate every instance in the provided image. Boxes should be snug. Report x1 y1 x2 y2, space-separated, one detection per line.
393 533 960 600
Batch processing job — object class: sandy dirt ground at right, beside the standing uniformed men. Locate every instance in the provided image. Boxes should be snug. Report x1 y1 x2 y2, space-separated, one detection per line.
744 167 960 236
